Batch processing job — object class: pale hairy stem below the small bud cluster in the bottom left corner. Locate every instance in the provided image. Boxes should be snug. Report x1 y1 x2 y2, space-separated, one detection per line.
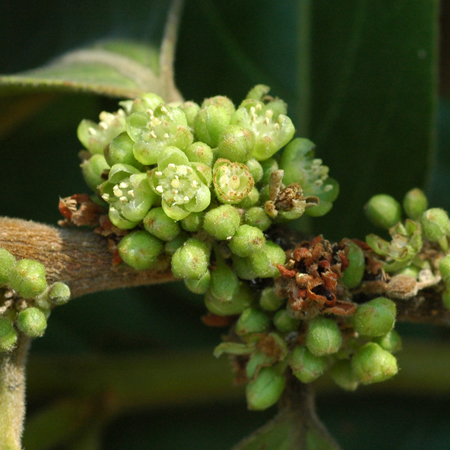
0 333 30 450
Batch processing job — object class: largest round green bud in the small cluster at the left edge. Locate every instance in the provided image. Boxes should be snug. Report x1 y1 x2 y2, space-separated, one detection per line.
9 259 47 298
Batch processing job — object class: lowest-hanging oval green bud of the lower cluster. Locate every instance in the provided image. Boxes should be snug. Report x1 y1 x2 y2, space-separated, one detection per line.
245 367 286 411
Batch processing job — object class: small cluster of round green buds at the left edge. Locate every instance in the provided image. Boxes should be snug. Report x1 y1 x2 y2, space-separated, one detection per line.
0 248 70 352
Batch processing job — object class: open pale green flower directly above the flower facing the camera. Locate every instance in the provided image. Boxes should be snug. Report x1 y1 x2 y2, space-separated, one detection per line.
127 105 194 165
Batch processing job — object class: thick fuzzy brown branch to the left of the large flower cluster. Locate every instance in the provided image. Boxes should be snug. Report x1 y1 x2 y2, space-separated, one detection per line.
0 217 174 298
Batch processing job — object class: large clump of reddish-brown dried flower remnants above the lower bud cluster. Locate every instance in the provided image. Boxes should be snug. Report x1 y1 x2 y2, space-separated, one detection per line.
275 236 356 319
